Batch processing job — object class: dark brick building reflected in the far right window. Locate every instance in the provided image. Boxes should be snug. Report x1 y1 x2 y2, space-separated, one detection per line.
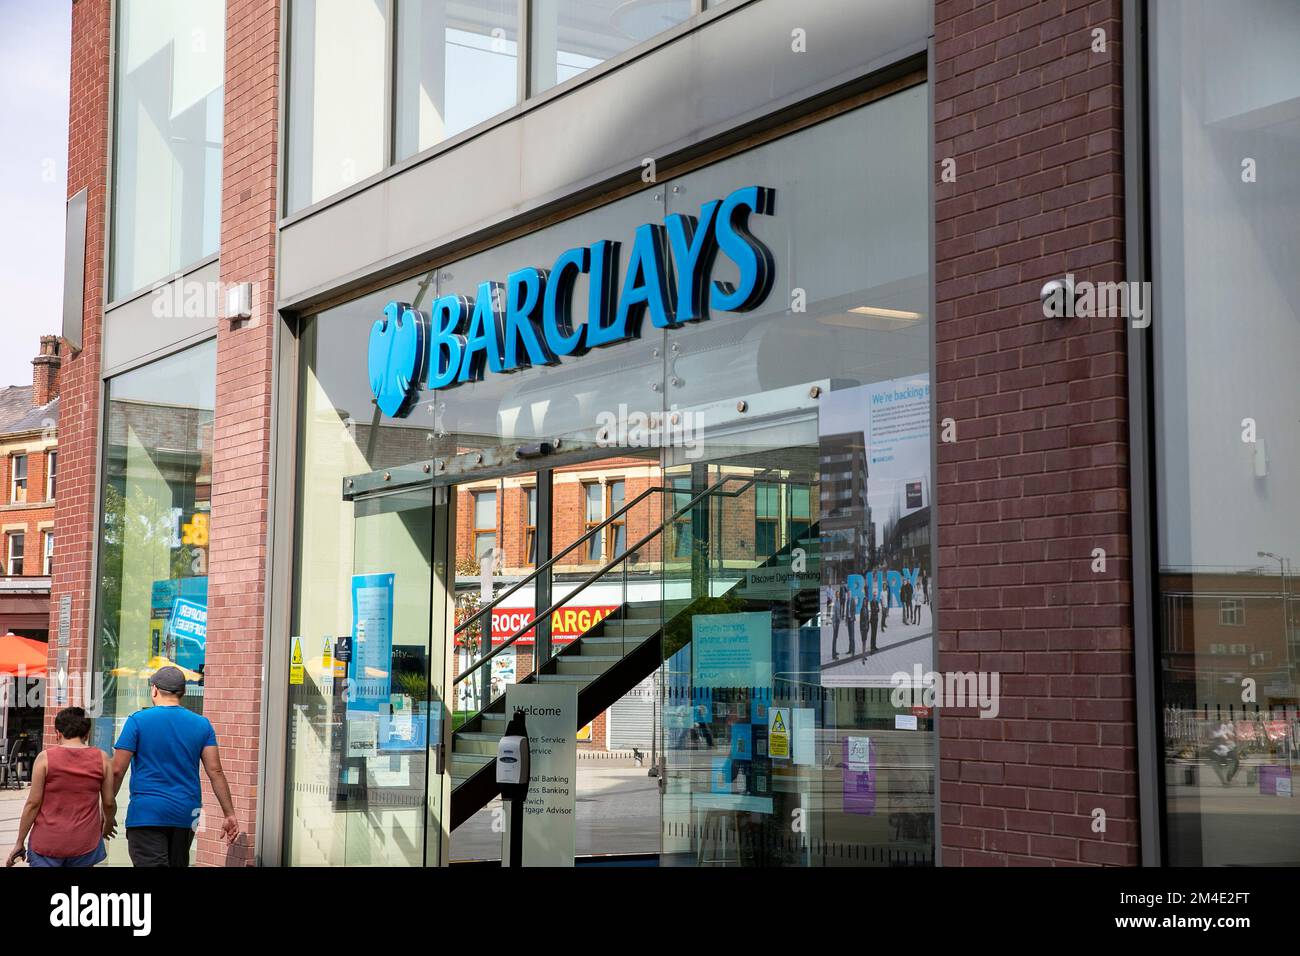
1158 568 1300 709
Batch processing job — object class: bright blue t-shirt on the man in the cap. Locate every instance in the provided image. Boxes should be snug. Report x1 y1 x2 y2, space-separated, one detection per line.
117 706 217 827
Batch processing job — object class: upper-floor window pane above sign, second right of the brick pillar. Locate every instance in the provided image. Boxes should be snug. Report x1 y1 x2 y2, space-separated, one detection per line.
397 0 519 160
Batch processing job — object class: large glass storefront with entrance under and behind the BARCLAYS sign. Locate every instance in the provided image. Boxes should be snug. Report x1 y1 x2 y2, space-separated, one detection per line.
285 78 937 866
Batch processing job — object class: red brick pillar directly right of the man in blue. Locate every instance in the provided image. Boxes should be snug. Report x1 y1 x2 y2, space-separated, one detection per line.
198 0 280 865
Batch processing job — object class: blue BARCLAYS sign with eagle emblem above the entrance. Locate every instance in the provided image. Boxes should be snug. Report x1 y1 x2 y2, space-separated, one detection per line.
367 186 776 416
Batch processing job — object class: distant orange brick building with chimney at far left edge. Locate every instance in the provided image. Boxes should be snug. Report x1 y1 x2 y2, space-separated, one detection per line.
0 336 62 639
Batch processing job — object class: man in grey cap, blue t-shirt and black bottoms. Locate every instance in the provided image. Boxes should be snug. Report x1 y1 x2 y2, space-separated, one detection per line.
113 667 239 866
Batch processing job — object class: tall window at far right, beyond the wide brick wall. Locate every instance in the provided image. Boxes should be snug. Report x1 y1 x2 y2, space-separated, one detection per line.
1148 0 1300 866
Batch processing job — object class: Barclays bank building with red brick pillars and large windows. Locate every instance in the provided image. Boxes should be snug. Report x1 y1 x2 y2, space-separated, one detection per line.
48 0 1300 866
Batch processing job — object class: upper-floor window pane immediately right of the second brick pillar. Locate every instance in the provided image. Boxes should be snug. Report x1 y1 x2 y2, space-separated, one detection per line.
287 0 389 212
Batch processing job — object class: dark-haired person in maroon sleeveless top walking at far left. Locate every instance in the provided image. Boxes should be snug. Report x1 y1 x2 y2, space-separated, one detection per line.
5 708 117 866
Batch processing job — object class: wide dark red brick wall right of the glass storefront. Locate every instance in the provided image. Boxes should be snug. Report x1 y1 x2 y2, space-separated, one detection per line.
933 0 1138 866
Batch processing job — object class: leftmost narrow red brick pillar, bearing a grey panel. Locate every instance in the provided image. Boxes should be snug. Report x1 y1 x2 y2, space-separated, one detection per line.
40 0 111 740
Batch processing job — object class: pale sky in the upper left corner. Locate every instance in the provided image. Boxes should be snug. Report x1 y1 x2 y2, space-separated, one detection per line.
0 0 72 386
